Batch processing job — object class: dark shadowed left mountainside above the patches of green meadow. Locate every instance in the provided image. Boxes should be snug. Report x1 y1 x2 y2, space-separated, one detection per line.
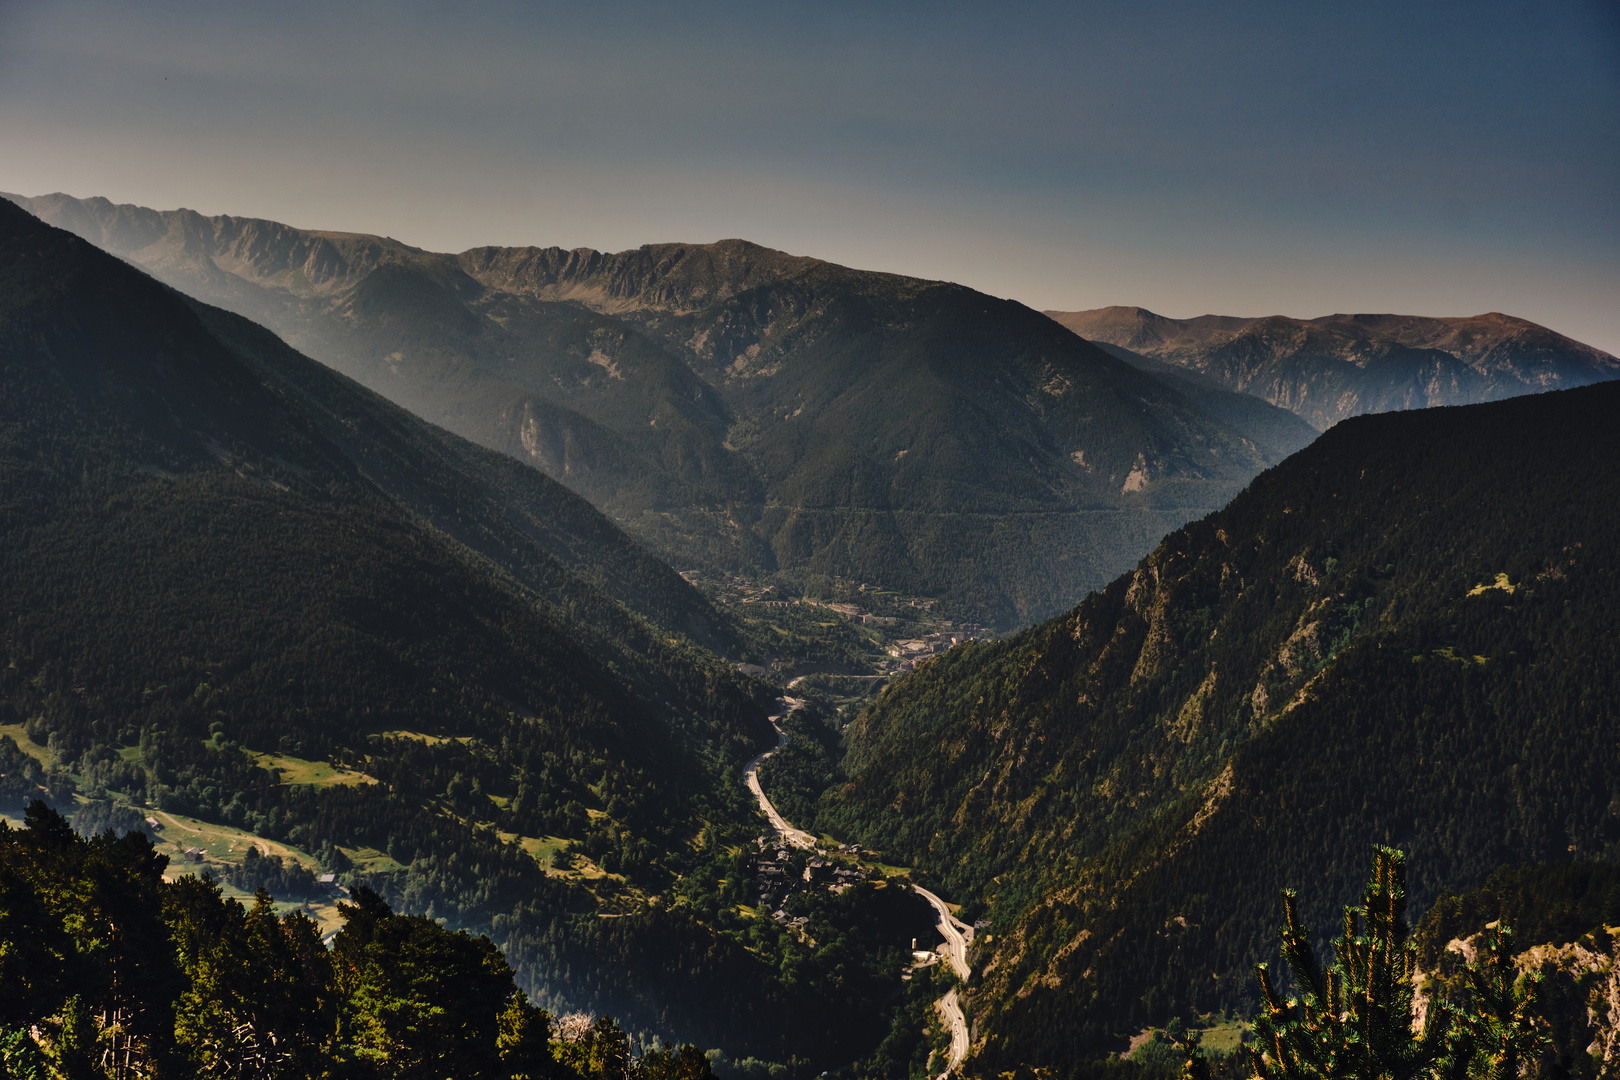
0 194 763 848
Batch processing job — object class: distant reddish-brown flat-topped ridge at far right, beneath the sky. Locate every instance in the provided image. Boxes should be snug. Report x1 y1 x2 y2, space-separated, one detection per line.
1047 308 1620 429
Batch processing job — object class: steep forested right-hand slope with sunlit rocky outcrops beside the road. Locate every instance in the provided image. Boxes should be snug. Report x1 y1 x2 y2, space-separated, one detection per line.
816 384 1620 1074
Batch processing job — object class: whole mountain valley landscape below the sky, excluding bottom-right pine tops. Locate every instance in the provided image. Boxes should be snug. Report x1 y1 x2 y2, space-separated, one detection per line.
0 196 1620 1080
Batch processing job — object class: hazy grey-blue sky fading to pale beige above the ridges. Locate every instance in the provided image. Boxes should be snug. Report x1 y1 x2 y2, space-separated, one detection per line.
0 0 1620 353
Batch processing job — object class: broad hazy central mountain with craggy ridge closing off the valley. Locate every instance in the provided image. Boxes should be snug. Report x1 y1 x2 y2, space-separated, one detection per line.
3 196 1312 625
